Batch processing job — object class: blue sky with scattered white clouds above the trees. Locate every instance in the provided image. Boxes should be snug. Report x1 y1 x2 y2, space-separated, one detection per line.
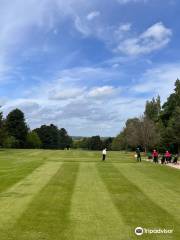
0 0 180 136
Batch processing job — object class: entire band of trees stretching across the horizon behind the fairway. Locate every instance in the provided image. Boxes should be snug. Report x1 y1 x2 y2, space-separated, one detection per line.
0 79 180 153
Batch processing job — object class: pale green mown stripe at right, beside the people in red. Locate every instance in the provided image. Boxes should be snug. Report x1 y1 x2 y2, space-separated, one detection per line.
115 164 180 221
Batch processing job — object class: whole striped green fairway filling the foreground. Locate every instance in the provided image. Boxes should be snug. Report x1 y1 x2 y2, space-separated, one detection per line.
0 149 180 240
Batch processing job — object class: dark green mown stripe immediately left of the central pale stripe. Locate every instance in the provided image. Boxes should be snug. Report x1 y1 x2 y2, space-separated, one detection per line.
0 163 78 240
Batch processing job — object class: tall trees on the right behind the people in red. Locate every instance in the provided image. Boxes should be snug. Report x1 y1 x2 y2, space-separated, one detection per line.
112 79 180 153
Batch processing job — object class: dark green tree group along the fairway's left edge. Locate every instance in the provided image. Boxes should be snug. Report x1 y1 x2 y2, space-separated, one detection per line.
0 109 72 149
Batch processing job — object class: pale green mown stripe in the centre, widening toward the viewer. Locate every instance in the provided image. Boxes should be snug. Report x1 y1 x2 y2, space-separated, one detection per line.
70 163 127 240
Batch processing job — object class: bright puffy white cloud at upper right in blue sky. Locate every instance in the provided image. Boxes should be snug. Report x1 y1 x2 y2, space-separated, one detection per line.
117 22 172 56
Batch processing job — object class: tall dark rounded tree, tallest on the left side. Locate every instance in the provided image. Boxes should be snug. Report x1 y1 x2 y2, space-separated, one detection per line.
5 109 28 148
